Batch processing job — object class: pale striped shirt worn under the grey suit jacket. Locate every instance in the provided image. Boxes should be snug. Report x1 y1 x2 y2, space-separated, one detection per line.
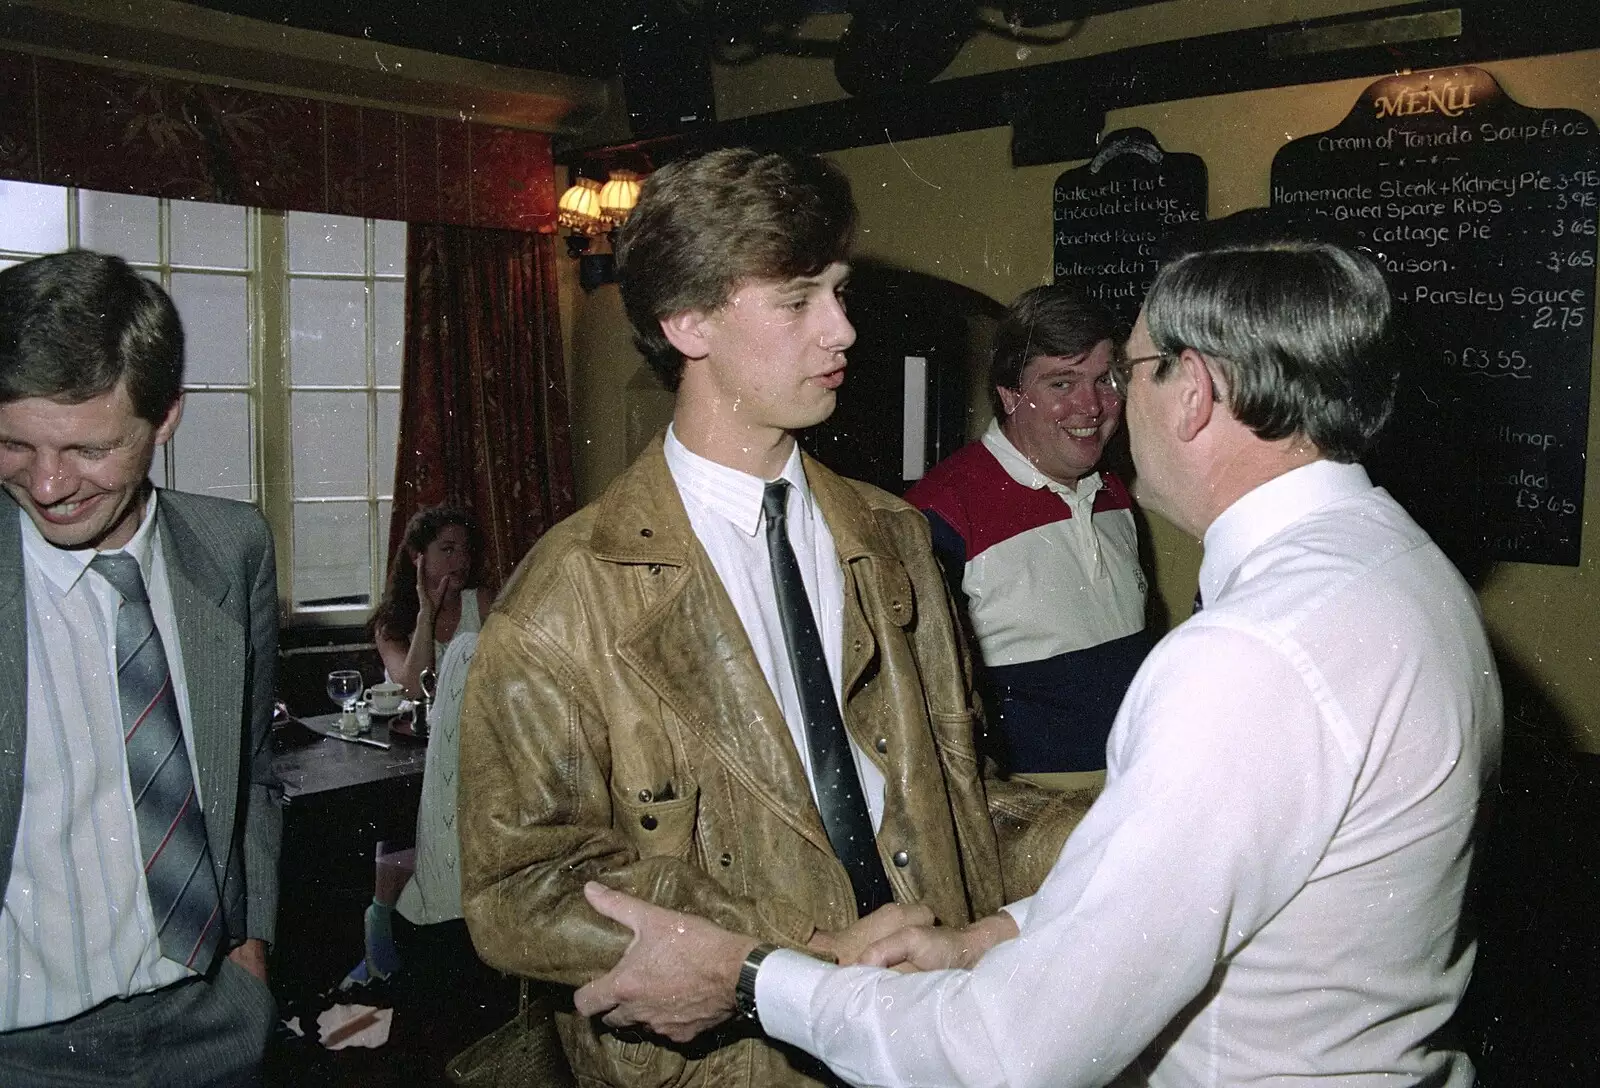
0 493 200 1030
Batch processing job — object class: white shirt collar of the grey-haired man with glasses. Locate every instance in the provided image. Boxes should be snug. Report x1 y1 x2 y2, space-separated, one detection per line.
1200 461 1373 603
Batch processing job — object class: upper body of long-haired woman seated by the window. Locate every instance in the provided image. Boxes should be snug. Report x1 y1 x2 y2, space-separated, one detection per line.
371 506 494 699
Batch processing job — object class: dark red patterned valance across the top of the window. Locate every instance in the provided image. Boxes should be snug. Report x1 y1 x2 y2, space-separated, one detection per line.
0 48 555 232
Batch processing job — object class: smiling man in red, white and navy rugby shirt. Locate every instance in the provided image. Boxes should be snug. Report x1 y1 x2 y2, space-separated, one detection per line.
906 286 1150 789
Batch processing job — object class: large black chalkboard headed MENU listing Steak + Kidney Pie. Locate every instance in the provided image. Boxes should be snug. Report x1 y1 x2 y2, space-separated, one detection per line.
1272 67 1600 566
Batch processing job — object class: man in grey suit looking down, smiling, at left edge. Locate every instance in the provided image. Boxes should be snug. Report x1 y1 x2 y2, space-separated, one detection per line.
0 250 282 1088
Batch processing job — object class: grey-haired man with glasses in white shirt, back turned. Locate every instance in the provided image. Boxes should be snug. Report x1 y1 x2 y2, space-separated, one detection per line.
578 214 1501 1088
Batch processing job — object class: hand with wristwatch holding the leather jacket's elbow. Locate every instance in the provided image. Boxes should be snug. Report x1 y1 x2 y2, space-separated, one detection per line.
574 880 758 1043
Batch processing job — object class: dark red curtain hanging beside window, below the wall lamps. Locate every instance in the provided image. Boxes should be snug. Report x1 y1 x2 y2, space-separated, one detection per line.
389 224 574 587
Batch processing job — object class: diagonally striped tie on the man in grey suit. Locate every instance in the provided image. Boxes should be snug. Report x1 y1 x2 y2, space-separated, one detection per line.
90 552 222 971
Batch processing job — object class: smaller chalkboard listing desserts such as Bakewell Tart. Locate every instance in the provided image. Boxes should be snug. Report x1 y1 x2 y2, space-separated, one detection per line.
1053 128 1206 326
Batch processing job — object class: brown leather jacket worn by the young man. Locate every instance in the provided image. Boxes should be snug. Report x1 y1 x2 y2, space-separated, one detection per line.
461 438 1082 1088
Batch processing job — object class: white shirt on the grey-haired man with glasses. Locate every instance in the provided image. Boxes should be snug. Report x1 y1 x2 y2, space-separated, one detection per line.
757 462 1501 1088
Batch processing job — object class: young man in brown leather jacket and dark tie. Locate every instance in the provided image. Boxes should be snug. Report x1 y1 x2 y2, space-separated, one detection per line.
461 149 1083 1088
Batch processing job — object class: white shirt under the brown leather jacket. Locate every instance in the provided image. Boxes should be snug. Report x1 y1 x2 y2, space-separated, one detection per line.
666 426 883 830
